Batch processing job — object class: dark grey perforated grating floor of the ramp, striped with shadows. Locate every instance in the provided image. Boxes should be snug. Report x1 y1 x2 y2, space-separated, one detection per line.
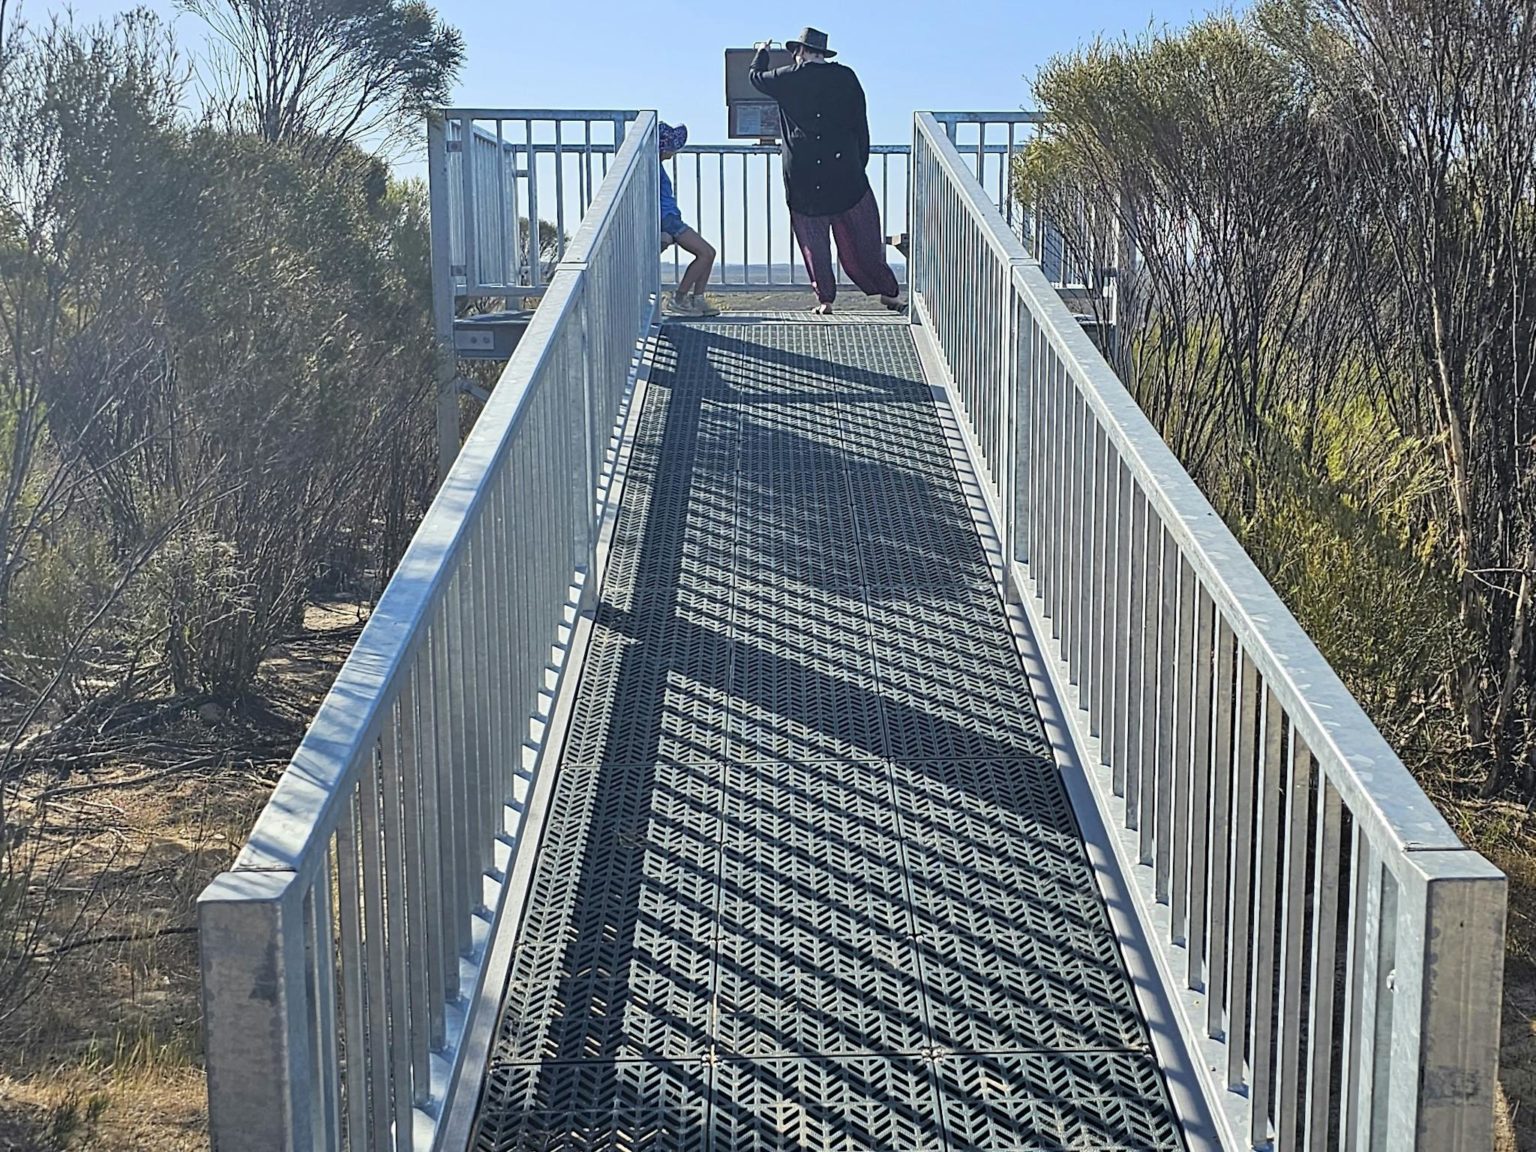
475 321 1184 1152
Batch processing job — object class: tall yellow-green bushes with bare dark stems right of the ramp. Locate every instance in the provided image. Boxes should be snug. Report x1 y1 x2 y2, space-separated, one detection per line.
1015 0 1536 797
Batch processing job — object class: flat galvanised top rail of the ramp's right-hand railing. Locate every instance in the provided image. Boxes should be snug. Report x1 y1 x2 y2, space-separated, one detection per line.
917 114 1475 865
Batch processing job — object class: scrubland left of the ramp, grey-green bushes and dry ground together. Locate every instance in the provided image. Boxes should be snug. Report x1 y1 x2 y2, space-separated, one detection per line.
0 0 462 1149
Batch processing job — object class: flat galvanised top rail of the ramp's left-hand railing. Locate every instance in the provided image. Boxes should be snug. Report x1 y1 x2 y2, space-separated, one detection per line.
230 114 654 872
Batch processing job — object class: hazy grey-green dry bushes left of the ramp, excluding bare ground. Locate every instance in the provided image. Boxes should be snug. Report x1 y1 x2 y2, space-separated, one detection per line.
0 6 435 1056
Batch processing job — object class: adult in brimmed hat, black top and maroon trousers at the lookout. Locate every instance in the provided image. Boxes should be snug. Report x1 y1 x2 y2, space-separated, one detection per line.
748 28 905 315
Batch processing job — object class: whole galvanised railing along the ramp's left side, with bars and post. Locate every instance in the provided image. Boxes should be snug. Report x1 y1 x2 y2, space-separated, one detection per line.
198 114 659 1152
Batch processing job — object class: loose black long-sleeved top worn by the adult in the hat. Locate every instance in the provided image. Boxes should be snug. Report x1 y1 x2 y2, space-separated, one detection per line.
748 49 869 217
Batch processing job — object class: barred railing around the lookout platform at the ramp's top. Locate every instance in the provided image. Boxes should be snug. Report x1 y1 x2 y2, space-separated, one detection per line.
429 108 1094 302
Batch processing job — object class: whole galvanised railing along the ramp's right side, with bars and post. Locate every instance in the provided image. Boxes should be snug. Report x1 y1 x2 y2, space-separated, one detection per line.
912 115 1505 1152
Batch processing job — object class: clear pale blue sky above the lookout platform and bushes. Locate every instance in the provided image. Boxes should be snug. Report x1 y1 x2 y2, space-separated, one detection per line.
38 0 1223 154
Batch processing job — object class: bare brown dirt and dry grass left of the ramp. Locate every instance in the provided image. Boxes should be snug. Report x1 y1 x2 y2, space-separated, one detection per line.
0 604 361 1152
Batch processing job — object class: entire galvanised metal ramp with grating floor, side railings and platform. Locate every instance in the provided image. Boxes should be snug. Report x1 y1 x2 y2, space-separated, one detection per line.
198 109 1505 1152
